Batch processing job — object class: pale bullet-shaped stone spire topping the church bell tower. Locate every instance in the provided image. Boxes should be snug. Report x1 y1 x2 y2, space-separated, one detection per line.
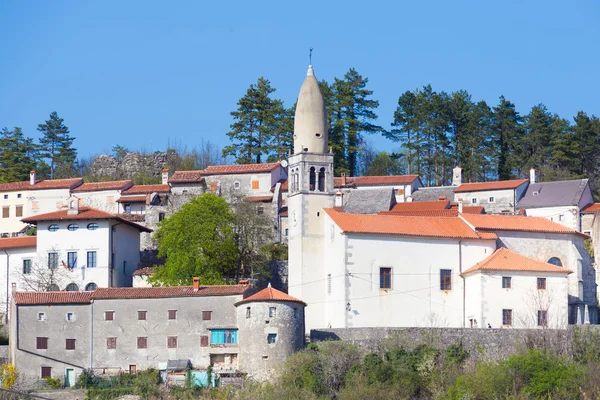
294 65 329 154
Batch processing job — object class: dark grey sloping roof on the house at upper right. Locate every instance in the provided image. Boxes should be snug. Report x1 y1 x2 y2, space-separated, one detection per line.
517 179 588 209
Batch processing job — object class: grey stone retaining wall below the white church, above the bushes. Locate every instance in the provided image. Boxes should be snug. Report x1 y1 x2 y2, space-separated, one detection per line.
310 325 600 361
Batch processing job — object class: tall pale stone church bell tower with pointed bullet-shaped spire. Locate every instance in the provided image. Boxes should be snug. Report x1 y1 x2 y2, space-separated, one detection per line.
288 65 335 330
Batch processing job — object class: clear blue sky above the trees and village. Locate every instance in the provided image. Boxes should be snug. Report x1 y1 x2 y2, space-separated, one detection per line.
0 0 600 157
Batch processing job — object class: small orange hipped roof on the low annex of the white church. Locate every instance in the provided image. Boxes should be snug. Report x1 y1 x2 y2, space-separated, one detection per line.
462 248 571 275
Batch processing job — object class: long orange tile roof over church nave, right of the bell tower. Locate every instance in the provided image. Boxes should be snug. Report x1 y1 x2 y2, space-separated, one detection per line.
324 208 492 239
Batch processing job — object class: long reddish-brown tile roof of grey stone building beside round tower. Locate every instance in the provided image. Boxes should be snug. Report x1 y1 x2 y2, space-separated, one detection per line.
13 285 252 305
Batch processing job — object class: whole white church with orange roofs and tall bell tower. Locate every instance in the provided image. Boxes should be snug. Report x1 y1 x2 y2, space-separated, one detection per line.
288 66 598 331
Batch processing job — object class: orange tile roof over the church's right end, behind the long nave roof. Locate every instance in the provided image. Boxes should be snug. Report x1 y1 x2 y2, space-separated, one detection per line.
461 214 588 237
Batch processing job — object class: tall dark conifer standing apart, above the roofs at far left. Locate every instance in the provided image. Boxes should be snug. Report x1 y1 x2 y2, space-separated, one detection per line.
37 111 77 179
